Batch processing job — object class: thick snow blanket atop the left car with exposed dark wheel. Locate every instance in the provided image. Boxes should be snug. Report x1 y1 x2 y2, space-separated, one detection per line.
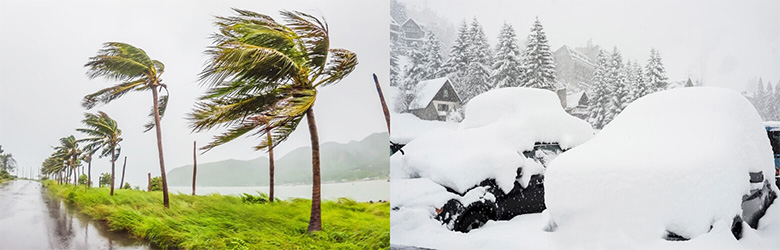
391 88 593 193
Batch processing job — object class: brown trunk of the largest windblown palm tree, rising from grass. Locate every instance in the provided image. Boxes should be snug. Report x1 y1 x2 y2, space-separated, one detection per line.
306 106 322 232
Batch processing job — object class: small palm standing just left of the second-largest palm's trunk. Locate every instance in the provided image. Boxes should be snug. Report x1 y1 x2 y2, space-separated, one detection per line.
76 111 122 196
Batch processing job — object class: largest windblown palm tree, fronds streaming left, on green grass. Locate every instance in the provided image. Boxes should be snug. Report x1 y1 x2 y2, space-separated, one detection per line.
189 9 358 232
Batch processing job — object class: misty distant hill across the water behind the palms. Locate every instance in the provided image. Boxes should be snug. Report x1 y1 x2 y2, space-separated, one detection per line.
167 133 390 187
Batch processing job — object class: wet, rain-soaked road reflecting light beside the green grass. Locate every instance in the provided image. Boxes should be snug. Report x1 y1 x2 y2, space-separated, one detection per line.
0 180 154 249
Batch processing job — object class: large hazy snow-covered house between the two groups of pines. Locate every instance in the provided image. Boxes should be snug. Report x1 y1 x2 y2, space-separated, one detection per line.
553 45 598 91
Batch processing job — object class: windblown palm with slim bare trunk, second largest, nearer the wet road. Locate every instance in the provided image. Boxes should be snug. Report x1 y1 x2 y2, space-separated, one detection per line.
82 42 169 208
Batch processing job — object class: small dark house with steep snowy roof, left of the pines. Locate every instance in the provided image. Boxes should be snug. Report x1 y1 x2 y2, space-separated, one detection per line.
409 77 462 121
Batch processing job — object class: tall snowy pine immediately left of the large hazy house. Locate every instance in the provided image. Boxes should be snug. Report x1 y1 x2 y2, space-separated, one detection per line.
523 17 555 90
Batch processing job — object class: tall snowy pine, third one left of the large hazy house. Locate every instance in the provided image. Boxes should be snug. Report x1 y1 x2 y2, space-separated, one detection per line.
461 17 493 102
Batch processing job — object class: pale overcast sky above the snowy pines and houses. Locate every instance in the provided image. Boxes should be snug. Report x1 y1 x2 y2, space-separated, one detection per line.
400 0 780 91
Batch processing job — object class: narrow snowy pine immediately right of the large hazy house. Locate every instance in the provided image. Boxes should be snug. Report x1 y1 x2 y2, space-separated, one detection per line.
588 50 610 129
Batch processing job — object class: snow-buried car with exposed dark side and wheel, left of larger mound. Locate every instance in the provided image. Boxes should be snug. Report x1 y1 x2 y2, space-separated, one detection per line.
391 88 593 232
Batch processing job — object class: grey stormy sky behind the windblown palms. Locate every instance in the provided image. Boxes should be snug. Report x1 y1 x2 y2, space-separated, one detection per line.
0 0 389 186
